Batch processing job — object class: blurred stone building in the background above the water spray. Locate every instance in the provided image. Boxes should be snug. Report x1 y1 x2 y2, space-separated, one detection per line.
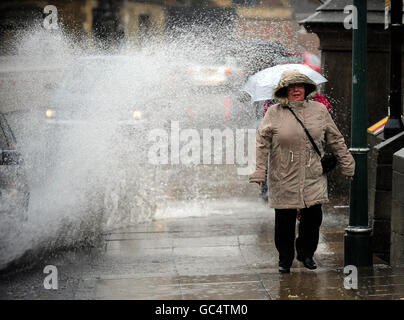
0 0 318 54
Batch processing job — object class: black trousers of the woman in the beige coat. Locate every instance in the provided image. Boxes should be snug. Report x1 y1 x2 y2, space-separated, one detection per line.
275 204 323 267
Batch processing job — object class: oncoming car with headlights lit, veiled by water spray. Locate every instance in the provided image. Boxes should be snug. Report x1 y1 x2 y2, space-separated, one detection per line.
44 56 159 127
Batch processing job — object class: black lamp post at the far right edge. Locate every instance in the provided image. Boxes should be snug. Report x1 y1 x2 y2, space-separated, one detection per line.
384 0 404 139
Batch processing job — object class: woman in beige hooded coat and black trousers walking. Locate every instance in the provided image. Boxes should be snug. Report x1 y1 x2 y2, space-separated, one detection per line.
250 70 355 273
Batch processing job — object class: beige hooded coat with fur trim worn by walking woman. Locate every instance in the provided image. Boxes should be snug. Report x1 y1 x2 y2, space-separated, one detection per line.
250 70 355 209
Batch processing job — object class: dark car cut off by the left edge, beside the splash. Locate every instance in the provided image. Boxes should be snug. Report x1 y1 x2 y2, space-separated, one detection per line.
0 113 30 222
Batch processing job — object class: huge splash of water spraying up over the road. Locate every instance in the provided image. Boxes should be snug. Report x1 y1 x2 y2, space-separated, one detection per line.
0 21 290 266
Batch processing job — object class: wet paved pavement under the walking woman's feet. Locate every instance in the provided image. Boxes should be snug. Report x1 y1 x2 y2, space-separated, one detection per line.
0 197 404 300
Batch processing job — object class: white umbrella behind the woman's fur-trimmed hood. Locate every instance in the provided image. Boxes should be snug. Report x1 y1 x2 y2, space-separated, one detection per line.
241 63 328 101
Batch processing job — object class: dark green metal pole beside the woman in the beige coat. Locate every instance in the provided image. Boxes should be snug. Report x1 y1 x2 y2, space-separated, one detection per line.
344 0 373 267
